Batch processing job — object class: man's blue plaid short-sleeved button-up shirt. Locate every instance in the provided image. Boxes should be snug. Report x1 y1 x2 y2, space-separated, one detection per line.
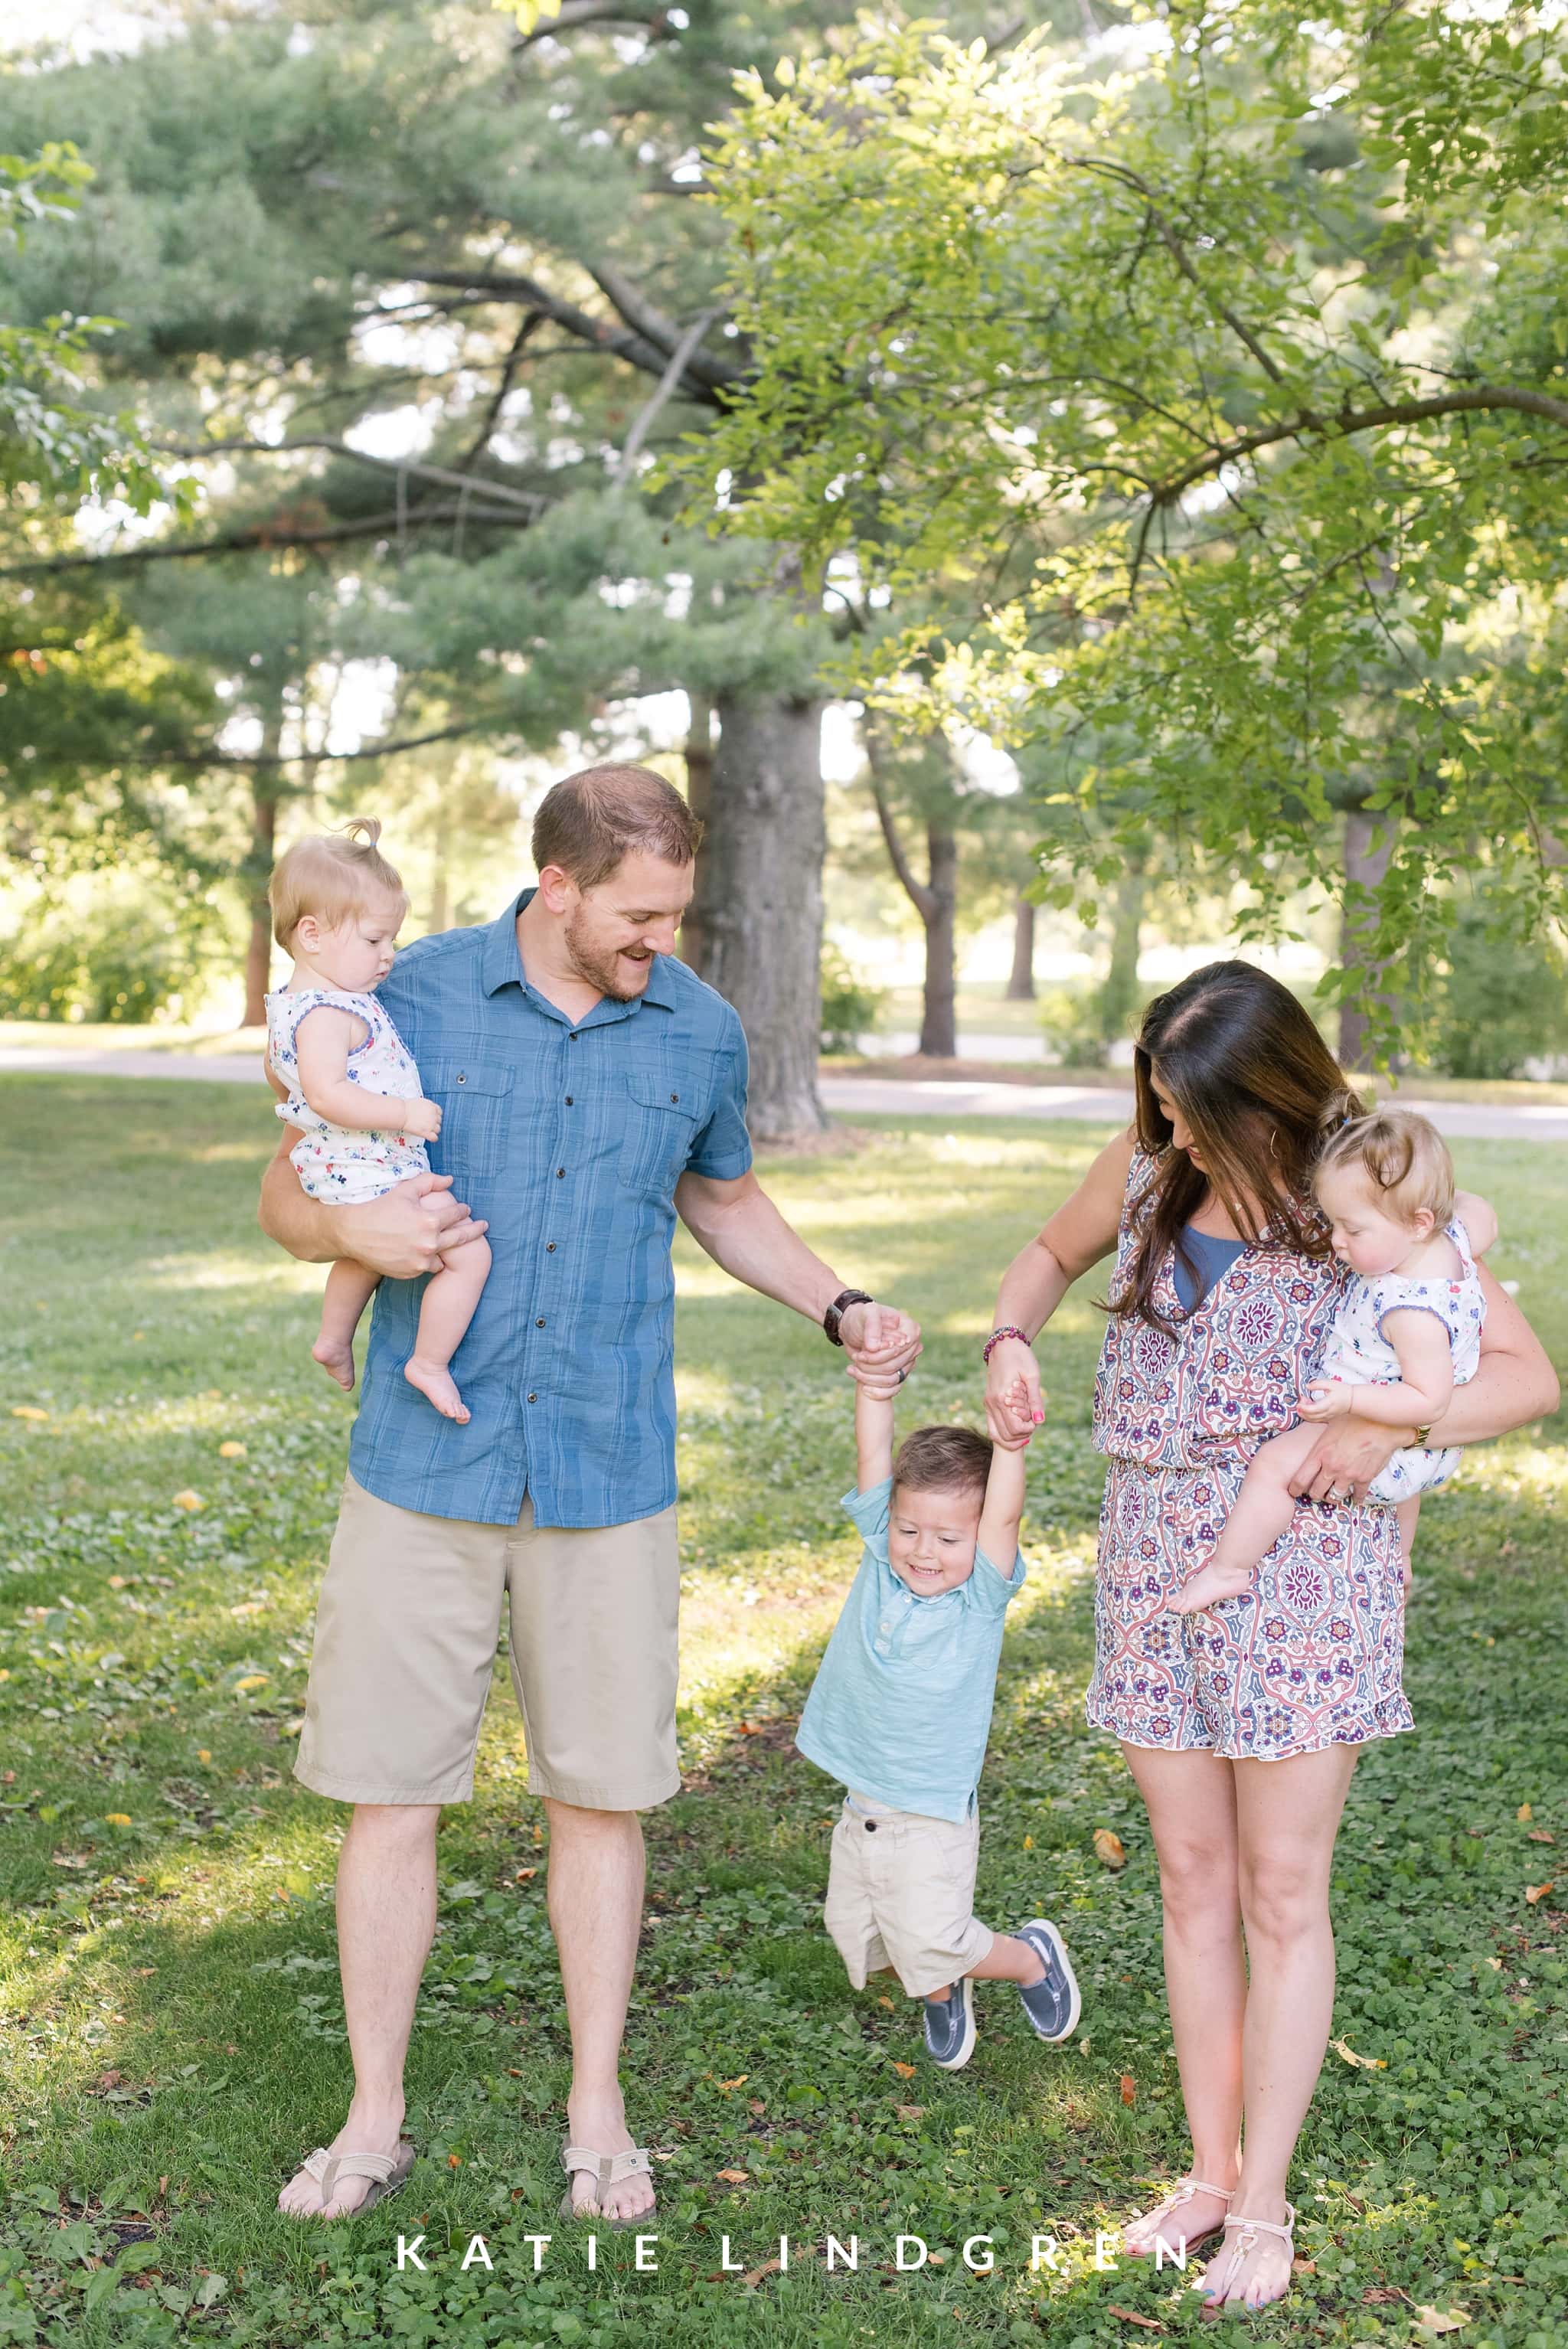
350 890 751 1524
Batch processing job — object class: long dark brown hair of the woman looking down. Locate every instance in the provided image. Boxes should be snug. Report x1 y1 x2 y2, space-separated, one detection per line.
1108 963 1361 1329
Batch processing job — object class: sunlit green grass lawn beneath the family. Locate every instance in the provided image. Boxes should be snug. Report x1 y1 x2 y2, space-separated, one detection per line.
0 1076 1568 2349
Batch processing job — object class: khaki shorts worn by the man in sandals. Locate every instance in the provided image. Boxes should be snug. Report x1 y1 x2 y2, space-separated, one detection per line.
293 1478 681 1811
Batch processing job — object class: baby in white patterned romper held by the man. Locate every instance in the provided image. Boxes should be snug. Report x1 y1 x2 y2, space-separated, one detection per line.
268 818 491 1421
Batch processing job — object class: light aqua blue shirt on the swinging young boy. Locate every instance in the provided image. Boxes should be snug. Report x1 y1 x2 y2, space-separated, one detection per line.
795 1478 1024 1823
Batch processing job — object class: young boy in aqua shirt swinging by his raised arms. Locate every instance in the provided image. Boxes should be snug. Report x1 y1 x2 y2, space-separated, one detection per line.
795 1386 1080 2072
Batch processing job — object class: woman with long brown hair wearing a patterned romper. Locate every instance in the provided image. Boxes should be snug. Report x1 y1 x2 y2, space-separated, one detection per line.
986 963 1557 2314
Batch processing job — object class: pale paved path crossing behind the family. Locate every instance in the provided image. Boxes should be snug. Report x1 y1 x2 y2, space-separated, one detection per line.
0 1045 1568 1142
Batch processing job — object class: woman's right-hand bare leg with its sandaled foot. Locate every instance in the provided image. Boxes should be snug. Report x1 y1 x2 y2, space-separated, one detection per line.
1204 1746 1357 2309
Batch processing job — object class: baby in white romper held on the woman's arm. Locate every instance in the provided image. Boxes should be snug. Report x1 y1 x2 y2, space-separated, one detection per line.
1171 1109 1498 1614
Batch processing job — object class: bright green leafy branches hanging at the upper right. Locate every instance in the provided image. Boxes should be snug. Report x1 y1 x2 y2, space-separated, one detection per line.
688 0 1568 1066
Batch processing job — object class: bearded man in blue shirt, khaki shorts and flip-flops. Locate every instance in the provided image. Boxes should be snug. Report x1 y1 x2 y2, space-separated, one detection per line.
260 766 920 2222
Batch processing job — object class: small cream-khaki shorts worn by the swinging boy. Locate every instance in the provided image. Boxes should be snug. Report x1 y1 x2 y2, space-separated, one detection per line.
822 1792 993 1999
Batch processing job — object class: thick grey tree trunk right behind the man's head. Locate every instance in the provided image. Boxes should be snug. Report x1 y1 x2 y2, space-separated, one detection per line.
688 695 826 1142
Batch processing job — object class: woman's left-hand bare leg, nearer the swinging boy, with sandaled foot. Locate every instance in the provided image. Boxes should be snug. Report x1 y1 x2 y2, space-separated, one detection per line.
1122 1746 1246 2255
